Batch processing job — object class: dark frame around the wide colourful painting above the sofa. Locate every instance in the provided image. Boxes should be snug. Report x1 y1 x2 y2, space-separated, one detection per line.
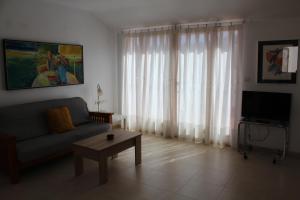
2 39 84 90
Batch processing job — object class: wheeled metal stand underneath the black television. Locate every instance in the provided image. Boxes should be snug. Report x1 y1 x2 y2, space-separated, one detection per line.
238 119 289 164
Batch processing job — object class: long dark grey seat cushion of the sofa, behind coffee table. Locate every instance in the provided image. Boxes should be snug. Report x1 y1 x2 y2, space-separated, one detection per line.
17 122 111 162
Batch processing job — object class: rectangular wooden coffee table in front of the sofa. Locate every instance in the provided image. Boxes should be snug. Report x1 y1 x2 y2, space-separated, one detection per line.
72 130 142 184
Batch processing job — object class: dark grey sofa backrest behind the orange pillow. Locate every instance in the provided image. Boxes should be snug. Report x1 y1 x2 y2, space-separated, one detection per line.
0 97 89 141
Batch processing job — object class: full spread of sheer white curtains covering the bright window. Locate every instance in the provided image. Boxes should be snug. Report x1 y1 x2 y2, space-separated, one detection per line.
122 25 242 147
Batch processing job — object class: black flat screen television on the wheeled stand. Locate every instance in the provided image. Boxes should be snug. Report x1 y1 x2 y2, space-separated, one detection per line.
242 91 292 122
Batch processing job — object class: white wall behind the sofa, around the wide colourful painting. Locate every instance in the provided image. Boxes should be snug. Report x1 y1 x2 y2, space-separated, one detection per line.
0 0 116 111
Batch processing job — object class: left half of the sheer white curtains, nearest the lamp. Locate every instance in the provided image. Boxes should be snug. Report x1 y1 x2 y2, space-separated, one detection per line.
122 30 172 135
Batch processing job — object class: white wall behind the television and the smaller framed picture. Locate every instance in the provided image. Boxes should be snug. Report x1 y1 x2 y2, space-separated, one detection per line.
244 19 300 153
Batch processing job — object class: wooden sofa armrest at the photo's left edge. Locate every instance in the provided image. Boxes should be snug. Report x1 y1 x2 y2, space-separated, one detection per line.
0 134 19 183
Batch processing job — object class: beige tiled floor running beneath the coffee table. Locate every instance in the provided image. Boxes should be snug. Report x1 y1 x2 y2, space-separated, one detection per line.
0 135 300 200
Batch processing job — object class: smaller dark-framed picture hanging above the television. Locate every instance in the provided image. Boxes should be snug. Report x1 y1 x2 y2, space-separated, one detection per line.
257 40 298 83
